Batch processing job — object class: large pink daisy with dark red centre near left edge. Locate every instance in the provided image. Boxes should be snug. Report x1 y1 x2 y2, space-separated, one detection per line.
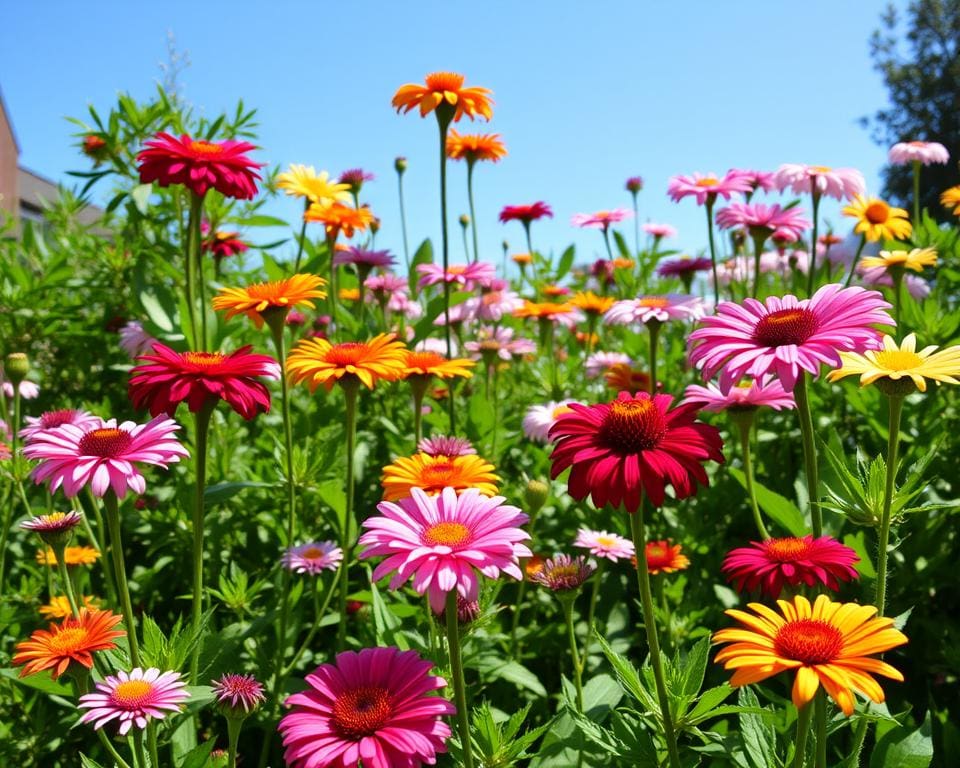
23 416 190 499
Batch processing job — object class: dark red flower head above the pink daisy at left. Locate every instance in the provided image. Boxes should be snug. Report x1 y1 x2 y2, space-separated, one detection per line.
129 342 280 420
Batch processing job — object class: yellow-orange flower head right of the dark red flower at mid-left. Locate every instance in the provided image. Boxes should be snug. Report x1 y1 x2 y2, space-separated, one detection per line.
287 333 406 392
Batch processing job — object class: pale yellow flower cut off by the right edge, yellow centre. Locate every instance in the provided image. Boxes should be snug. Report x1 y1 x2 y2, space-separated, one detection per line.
827 333 960 392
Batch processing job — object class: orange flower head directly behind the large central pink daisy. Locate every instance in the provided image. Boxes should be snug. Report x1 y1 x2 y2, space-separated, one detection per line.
380 453 500 501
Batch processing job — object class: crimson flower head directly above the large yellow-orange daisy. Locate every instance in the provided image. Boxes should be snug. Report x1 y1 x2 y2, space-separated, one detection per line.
721 536 860 599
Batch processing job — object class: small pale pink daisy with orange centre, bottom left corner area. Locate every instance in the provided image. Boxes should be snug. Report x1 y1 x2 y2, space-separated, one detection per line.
77 667 190 736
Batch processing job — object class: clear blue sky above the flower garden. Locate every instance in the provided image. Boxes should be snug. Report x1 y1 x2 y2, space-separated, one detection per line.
0 0 909 268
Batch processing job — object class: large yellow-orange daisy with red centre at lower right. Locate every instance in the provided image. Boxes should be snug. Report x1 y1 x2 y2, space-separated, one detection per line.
713 595 907 717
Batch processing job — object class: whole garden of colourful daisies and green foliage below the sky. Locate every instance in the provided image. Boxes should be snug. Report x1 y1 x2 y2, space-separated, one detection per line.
0 72 960 768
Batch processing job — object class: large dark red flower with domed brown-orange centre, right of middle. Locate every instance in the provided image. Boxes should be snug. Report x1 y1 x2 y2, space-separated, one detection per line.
549 392 723 512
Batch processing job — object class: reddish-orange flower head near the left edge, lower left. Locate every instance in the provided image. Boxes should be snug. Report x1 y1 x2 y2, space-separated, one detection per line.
12 608 126 680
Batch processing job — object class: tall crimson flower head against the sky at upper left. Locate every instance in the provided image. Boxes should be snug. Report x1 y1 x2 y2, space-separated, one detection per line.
137 131 261 200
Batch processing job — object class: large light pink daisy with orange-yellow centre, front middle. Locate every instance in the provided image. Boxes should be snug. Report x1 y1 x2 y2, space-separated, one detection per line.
359 488 533 613
